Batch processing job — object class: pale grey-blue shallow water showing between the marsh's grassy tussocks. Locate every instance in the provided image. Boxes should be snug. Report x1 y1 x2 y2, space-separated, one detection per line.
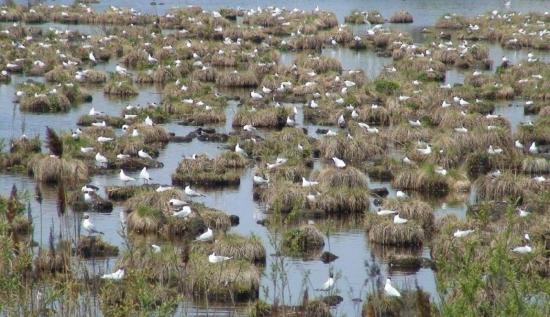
0 0 550 316
